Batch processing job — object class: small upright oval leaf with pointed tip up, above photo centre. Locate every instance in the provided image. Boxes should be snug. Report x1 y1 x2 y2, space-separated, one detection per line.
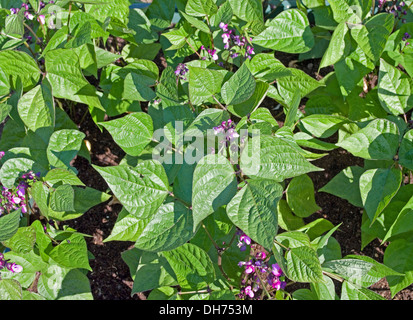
221 64 256 105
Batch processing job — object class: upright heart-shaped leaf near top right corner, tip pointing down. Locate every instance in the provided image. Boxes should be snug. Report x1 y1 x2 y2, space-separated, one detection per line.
351 13 394 62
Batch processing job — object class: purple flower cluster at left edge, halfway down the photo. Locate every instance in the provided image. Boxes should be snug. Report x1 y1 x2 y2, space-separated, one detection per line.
0 166 40 216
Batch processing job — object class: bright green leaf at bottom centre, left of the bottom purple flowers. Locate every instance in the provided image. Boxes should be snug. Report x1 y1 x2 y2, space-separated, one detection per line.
163 243 215 290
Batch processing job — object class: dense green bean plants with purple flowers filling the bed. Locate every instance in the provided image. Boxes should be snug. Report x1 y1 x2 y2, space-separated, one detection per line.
0 0 413 300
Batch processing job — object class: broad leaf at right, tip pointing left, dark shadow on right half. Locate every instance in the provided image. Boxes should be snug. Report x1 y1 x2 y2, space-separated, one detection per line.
337 119 399 160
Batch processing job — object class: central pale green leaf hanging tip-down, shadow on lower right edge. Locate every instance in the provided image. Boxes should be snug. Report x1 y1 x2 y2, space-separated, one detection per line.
192 154 237 230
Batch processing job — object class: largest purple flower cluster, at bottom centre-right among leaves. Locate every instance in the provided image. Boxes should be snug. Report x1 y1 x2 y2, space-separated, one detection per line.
238 251 286 298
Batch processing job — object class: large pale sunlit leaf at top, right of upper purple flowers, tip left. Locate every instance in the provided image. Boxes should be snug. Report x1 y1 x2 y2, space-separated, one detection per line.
253 9 314 53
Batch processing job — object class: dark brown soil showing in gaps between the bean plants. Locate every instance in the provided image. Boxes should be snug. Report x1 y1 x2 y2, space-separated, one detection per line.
58 47 413 300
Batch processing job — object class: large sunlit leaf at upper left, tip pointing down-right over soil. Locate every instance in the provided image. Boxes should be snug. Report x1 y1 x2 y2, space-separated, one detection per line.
45 49 104 110
